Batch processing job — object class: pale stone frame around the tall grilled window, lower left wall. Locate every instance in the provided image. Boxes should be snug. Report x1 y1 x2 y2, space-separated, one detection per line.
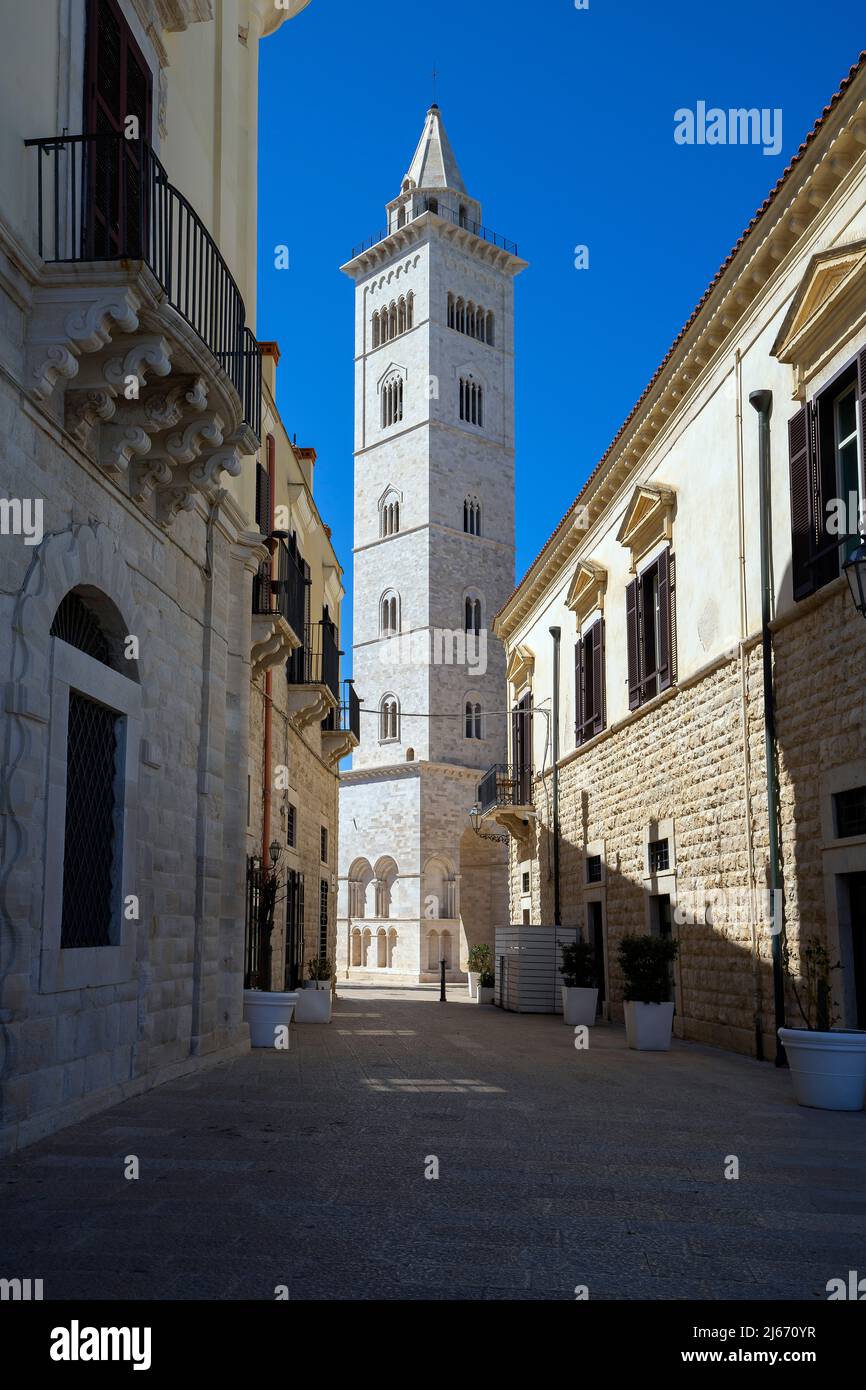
39 637 142 994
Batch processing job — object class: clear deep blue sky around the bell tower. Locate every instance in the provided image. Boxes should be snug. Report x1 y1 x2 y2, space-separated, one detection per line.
257 0 866 646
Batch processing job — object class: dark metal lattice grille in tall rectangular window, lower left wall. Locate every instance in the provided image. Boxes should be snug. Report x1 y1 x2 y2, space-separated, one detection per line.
60 691 118 948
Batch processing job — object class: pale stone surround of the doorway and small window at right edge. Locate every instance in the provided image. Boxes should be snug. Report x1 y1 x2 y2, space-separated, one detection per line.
819 758 866 1027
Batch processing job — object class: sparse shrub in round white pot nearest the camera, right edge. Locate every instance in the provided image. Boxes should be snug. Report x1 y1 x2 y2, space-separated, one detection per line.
778 937 866 1111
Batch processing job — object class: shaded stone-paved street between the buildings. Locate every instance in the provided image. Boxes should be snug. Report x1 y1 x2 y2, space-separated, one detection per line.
0 986 866 1300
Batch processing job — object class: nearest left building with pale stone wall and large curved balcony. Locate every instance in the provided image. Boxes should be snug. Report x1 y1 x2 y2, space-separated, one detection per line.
0 0 315 1150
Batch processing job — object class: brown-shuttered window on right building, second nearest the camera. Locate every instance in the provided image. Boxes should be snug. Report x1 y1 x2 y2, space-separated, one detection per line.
626 550 676 709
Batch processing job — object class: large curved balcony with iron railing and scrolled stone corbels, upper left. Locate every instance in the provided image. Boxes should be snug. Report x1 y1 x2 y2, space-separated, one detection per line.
26 132 261 527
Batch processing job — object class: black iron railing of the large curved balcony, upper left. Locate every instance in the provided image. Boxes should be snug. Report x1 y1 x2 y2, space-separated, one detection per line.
25 131 261 436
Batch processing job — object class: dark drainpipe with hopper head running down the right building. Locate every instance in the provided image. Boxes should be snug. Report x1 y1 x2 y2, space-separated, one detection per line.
749 391 787 1066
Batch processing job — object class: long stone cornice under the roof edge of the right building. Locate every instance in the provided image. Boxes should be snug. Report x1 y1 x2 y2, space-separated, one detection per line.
493 67 866 641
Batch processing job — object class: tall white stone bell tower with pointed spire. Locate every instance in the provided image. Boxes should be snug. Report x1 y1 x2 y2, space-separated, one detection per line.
338 106 525 980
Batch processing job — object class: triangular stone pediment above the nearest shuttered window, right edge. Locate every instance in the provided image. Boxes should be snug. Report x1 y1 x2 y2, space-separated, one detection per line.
770 240 866 395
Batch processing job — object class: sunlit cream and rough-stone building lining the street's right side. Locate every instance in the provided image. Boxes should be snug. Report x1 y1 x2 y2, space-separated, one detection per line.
478 51 866 1056
